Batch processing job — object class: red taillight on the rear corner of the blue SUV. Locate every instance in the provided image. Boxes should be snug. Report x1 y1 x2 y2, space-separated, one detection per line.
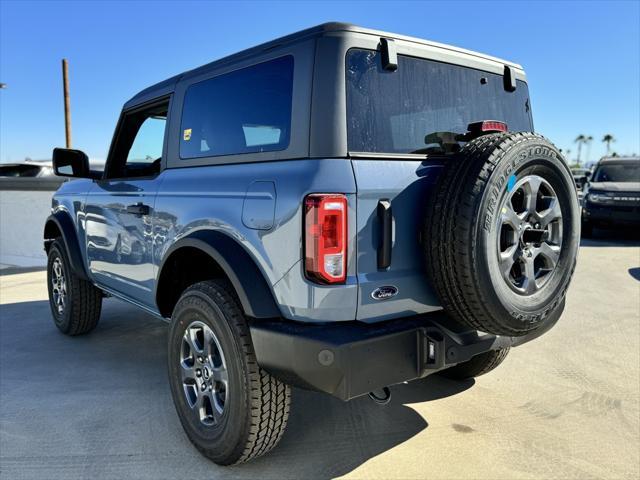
304 193 347 283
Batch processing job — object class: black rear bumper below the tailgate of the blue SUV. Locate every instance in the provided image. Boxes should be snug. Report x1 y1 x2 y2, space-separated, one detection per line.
251 313 557 400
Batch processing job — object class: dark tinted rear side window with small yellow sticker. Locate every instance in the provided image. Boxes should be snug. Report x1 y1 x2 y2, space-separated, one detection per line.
180 56 293 159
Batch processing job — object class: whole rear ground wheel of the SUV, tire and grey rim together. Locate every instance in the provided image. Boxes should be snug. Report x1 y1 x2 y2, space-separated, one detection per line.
168 281 291 465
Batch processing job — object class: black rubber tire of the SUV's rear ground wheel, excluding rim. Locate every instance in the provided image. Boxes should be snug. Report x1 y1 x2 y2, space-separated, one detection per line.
168 281 291 465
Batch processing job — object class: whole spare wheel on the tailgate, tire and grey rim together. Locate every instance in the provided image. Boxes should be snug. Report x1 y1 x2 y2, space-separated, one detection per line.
423 133 580 336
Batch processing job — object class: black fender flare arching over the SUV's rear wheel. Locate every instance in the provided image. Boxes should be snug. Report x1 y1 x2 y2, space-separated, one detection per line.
154 230 282 318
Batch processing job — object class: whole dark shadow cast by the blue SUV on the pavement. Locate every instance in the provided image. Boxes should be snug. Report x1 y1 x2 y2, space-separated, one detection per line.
0 299 474 479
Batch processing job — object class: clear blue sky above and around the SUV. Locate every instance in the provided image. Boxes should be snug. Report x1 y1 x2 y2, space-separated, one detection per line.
0 0 640 162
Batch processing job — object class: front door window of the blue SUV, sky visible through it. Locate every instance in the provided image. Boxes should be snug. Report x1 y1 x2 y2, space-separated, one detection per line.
107 101 169 178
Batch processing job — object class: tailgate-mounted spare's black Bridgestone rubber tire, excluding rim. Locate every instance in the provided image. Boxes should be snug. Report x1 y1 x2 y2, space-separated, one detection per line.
422 133 580 336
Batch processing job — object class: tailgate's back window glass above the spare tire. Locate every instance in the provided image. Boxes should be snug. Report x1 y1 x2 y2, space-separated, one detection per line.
347 49 533 153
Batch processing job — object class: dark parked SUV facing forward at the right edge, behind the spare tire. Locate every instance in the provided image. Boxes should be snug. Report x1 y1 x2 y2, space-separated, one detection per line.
582 157 640 237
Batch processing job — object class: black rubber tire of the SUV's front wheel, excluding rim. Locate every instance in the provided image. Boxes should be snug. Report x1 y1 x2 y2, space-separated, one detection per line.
47 239 103 336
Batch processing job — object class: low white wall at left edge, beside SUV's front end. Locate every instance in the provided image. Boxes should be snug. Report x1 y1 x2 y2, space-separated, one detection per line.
0 190 54 267
